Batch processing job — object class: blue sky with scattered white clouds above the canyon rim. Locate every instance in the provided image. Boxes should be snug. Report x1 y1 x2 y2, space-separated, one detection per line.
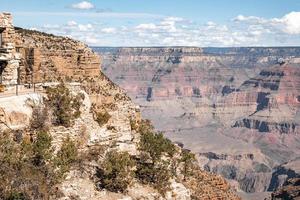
0 0 300 46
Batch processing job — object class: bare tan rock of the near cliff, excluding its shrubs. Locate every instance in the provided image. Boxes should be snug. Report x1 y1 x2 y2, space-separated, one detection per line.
0 28 239 200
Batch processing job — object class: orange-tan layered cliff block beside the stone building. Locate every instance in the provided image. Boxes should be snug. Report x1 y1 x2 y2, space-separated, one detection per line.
16 28 100 83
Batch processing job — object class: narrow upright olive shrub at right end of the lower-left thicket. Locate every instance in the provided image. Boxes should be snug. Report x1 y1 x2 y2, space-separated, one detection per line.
55 137 78 177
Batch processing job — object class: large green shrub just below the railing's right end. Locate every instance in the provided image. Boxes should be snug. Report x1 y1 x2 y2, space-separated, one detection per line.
45 83 83 127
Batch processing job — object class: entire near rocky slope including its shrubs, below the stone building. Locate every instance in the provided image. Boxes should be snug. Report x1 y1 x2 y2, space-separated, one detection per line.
0 28 239 200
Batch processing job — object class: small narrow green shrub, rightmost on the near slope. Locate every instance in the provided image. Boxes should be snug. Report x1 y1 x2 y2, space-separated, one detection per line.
180 149 196 180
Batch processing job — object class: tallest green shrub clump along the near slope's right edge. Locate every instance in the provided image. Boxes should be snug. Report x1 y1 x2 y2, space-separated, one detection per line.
136 121 176 194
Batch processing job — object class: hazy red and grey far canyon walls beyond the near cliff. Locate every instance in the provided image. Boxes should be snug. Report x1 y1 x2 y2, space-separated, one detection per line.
94 47 300 198
